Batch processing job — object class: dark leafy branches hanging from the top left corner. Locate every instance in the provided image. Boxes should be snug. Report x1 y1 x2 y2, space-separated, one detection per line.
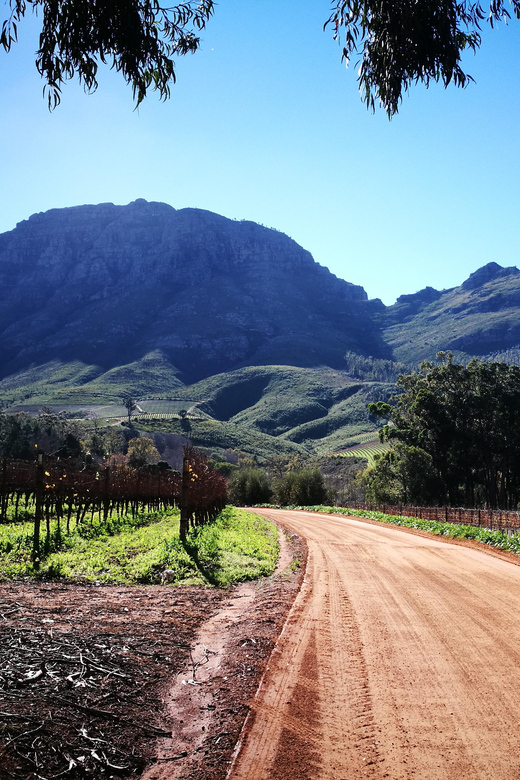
0 0 213 108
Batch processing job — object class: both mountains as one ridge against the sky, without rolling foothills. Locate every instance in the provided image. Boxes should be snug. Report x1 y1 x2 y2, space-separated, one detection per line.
0 199 520 408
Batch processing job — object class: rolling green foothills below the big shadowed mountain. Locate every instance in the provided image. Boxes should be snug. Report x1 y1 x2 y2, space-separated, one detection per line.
0 362 395 462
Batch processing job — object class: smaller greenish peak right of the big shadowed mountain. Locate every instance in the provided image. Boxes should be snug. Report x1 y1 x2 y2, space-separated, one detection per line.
384 262 520 365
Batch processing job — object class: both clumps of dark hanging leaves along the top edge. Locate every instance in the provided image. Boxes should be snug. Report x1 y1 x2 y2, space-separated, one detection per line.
0 0 520 116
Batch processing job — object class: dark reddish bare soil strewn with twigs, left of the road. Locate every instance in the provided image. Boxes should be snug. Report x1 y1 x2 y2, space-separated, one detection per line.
0 534 306 780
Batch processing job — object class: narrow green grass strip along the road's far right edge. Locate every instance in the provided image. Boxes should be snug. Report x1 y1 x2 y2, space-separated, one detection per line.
291 506 520 555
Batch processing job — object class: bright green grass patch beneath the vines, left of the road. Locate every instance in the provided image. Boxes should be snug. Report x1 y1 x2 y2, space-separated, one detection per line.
0 507 279 587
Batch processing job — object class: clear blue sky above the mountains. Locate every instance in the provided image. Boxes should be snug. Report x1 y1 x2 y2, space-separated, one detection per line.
0 0 520 304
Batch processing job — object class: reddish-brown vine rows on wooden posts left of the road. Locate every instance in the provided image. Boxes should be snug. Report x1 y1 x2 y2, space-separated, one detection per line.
0 448 226 568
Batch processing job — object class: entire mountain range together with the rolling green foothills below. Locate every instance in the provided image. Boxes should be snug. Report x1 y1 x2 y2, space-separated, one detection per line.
0 200 520 457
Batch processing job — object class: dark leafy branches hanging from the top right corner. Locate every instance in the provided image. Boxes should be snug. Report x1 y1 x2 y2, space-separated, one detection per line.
327 0 520 116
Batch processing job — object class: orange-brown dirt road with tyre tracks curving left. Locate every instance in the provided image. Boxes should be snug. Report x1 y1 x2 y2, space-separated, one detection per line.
229 510 520 780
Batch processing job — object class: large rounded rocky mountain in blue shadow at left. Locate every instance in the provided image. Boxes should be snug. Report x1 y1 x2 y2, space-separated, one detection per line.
0 200 388 386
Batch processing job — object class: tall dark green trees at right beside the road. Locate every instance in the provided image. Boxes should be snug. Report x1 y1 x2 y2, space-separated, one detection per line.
369 352 520 509
